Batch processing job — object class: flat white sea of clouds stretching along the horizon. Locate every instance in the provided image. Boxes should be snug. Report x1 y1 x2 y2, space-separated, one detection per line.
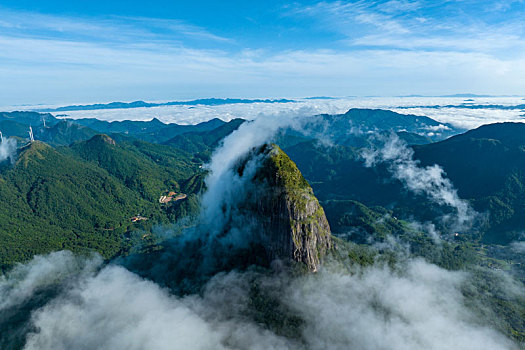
2 97 525 129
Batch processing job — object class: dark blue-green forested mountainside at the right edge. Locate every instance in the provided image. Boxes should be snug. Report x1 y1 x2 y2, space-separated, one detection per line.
414 123 525 243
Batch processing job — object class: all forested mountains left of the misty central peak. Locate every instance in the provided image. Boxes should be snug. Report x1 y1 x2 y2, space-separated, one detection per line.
0 112 252 269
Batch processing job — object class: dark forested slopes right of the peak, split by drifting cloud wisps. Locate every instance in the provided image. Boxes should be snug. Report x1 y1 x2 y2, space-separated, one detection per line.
285 123 525 243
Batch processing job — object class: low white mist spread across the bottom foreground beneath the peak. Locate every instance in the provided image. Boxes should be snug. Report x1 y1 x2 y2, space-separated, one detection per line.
0 253 517 349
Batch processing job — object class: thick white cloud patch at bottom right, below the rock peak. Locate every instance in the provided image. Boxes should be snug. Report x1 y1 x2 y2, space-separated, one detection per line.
292 260 513 349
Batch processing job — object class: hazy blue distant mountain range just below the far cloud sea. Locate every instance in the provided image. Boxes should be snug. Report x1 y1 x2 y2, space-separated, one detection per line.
0 109 458 148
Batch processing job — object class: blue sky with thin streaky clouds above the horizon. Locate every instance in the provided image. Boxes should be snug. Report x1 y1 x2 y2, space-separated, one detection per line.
0 0 525 105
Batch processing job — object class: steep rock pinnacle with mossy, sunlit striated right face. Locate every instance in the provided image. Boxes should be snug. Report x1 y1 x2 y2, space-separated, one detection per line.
238 145 332 271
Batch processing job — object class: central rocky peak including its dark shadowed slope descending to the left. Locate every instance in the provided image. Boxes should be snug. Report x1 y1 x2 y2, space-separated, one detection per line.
125 145 333 294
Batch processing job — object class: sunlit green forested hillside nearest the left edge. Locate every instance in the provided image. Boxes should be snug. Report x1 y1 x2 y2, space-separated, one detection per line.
0 142 143 267
